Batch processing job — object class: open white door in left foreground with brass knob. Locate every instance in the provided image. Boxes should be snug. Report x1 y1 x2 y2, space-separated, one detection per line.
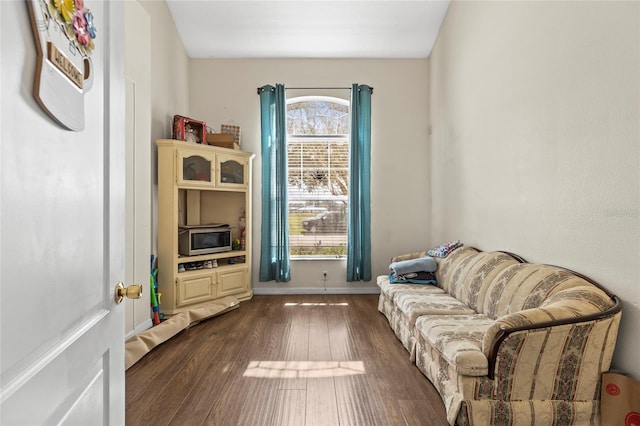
0 0 125 425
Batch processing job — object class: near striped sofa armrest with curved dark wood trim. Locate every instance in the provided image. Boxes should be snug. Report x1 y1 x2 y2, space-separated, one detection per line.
482 296 622 386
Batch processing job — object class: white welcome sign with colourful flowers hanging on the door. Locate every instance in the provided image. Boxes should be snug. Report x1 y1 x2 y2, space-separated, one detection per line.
27 0 96 131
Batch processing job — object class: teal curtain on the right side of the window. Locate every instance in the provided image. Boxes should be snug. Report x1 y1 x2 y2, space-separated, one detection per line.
347 84 373 281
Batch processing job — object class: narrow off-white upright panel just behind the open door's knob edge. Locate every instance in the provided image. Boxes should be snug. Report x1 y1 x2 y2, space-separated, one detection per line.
124 1 152 338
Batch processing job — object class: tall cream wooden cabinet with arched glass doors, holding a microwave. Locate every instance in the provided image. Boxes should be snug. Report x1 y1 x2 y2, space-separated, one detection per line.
156 139 254 314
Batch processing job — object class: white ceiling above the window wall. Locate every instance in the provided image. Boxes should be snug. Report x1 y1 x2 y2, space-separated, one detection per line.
166 0 449 58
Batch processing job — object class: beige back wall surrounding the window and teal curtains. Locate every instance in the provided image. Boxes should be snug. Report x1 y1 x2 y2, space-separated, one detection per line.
190 59 432 293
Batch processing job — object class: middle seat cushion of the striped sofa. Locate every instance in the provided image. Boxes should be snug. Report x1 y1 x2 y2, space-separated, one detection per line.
393 292 475 325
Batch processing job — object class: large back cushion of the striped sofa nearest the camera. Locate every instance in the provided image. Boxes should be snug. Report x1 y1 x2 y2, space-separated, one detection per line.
482 263 613 319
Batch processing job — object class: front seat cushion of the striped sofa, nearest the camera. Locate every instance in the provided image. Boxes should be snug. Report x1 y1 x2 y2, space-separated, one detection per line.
416 314 494 376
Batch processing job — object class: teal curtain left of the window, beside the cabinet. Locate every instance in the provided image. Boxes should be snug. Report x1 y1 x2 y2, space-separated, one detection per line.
258 84 291 282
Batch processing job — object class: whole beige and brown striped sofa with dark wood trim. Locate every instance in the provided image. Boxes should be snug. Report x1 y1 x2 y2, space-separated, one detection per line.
377 246 622 426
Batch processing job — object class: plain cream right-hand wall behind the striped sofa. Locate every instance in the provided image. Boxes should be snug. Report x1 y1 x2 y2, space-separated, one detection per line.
430 2 640 378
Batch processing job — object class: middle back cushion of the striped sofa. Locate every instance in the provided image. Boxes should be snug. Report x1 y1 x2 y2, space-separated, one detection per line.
449 251 519 312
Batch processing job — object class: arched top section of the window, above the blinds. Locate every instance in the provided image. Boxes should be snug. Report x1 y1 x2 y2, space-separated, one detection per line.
287 96 351 136
